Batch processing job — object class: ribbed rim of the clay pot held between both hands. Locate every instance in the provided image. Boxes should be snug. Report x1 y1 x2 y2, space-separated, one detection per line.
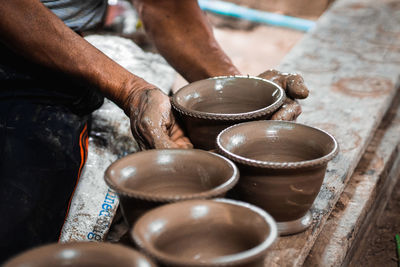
171 75 286 120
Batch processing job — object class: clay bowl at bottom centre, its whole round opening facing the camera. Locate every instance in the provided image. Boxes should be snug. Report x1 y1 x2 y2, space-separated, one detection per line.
131 198 278 267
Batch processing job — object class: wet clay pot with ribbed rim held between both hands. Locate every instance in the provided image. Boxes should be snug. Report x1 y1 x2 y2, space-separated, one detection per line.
172 76 285 150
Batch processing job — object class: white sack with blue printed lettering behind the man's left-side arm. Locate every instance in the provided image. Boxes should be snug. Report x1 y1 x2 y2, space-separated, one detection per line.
60 35 175 242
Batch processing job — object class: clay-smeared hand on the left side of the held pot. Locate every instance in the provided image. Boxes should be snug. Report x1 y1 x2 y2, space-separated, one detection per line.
127 88 193 149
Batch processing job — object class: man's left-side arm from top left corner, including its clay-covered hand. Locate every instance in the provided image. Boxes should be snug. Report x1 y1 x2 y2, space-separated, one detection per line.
0 0 190 148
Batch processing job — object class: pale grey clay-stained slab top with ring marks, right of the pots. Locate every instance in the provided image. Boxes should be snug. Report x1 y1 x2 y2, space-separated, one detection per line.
265 0 400 266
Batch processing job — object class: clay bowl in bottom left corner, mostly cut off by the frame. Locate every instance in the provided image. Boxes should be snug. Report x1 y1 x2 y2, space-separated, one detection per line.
4 241 156 267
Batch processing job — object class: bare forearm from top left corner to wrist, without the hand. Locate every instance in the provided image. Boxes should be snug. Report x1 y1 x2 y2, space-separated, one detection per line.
0 0 150 112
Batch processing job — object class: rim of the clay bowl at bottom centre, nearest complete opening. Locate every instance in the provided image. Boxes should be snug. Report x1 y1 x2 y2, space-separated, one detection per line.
131 198 278 267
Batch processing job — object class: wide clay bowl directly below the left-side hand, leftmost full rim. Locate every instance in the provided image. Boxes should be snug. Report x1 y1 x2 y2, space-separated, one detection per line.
104 149 239 225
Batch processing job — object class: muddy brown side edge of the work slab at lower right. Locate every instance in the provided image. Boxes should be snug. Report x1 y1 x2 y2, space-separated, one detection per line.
304 91 400 266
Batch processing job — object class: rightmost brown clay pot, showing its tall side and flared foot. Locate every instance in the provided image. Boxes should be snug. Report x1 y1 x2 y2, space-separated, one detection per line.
217 121 339 235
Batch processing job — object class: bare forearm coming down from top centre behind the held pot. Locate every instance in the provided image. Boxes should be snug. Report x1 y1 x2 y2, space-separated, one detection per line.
133 0 239 82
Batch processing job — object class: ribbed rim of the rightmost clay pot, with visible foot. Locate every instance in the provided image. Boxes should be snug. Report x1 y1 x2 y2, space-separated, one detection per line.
217 120 339 169
